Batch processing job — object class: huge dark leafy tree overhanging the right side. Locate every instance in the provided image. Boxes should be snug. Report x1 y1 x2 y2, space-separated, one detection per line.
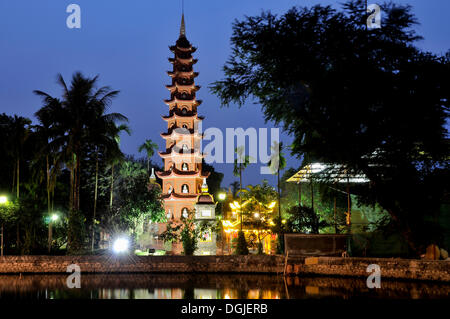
211 0 450 254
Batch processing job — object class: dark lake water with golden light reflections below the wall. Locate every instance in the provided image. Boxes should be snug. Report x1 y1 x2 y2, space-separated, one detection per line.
0 274 450 300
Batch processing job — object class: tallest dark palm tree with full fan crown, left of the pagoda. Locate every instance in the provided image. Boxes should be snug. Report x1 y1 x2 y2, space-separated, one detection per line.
34 72 126 249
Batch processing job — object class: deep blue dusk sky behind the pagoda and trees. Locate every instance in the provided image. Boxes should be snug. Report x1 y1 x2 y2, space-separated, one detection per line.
0 0 450 187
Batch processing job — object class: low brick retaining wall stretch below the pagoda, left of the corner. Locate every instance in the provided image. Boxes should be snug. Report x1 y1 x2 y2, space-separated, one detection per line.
0 255 284 273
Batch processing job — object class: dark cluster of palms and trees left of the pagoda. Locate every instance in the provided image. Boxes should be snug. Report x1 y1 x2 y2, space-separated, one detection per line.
0 72 163 254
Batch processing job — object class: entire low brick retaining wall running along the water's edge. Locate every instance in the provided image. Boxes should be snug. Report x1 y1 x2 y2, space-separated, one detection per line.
0 255 450 282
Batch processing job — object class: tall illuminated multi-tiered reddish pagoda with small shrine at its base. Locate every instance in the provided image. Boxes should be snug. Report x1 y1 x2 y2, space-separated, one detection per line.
156 15 215 254
